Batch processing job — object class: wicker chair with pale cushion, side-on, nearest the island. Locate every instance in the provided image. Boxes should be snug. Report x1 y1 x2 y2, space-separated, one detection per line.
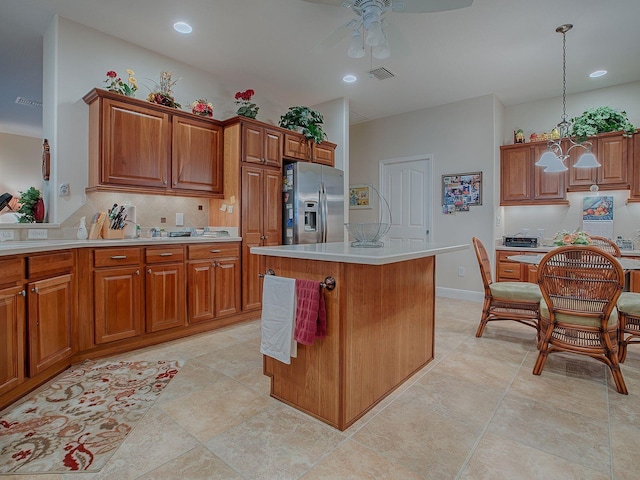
472 237 542 337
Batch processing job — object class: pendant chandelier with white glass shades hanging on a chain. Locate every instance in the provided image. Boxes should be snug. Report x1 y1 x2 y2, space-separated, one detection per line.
536 23 600 172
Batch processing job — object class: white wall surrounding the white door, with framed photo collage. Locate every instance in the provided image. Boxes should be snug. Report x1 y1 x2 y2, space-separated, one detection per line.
350 95 502 291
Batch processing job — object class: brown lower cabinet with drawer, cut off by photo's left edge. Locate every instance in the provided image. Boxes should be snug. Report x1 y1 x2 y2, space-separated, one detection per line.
0 257 26 395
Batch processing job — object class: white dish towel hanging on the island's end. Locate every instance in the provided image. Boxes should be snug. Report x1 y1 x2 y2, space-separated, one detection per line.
260 275 298 365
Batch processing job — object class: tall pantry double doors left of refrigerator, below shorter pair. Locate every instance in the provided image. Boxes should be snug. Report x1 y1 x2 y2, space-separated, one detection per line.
241 166 282 310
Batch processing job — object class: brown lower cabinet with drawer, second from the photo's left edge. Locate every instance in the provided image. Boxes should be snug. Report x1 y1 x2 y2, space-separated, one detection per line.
26 250 76 376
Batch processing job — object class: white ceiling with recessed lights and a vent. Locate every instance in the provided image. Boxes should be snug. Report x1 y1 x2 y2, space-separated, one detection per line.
0 0 640 135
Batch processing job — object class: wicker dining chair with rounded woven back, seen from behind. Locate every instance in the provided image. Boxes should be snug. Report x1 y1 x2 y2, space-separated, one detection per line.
533 246 627 394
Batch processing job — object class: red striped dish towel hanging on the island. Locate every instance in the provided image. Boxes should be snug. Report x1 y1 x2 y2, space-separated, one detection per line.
293 279 327 345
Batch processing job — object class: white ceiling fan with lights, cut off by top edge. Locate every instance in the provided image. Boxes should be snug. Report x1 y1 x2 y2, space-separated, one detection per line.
304 0 473 59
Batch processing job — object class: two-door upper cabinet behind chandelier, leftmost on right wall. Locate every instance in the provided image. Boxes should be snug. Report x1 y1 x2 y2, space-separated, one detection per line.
500 142 568 205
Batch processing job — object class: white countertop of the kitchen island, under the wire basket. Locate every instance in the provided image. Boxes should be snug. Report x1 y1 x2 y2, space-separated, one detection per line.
251 242 469 265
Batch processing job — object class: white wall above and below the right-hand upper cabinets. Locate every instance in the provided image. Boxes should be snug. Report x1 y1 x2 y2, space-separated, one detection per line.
498 82 640 244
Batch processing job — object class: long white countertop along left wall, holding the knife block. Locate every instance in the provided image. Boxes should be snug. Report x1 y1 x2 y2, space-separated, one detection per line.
0 237 242 256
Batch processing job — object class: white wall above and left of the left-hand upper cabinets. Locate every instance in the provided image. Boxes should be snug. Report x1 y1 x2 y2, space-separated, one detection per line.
43 17 288 223
